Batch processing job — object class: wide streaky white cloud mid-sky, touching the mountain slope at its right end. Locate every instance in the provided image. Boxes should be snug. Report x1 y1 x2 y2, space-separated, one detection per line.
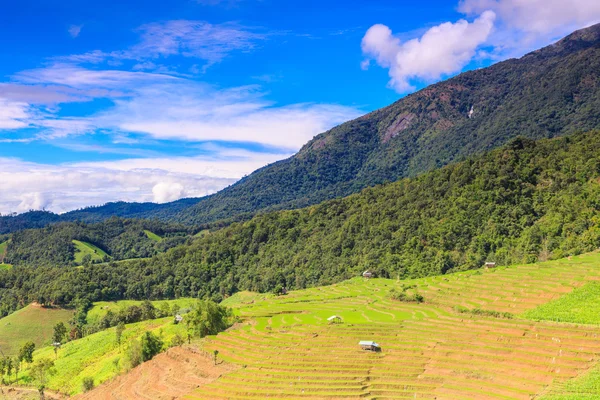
105 84 360 149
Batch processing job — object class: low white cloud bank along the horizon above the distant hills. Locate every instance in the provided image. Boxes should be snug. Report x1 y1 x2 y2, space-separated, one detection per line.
0 146 290 214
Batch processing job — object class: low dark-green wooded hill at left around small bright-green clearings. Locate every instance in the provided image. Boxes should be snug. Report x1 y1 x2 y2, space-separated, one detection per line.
0 217 192 267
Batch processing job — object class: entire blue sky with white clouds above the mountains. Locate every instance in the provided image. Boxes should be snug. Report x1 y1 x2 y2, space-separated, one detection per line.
0 0 600 214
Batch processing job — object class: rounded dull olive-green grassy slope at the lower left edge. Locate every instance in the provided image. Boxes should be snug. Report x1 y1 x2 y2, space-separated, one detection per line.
0 305 73 355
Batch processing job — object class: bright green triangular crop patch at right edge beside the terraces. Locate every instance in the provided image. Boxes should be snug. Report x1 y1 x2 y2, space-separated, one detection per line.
523 282 600 324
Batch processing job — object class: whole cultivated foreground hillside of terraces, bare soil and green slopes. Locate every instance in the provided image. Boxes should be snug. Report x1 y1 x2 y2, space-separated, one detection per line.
5 253 600 400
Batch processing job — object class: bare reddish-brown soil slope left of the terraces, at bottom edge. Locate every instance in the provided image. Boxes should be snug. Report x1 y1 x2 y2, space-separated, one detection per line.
74 346 237 400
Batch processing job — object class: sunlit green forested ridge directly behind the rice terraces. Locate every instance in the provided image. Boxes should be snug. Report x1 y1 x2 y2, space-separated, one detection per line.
0 131 600 312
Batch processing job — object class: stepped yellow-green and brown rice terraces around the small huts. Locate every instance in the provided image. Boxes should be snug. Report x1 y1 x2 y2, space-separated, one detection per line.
185 253 600 400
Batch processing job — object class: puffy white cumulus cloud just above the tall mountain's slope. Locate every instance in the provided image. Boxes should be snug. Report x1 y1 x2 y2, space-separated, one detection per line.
362 11 495 92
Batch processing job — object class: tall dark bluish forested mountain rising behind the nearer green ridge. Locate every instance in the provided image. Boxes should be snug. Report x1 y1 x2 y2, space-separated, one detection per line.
0 25 600 233
